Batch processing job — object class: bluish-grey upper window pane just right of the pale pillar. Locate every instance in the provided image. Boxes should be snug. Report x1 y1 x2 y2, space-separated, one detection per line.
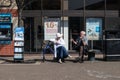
68 0 84 10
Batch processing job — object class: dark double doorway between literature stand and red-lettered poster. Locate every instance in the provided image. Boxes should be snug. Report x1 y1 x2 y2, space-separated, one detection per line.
24 17 43 53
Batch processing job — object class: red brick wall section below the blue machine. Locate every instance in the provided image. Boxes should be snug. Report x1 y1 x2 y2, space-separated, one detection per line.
0 41 14 57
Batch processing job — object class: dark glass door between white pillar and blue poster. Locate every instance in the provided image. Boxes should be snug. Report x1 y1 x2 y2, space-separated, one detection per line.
69 17 84 50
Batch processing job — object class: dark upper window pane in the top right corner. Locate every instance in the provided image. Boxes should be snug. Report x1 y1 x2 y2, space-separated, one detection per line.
106 0 120 10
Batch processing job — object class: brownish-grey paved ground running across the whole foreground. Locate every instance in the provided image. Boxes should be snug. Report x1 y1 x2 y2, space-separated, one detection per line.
0 54 120 80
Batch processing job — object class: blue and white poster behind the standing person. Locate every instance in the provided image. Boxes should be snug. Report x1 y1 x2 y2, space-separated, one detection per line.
86 18 102 40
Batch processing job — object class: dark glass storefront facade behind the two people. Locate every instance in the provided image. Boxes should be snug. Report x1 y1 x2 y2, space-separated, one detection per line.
0 0 120 56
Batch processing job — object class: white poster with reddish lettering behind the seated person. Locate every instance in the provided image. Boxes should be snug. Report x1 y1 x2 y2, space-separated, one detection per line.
44 18 60 40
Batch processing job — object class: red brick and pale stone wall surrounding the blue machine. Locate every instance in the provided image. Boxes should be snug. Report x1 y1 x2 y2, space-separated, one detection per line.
0 0 18 56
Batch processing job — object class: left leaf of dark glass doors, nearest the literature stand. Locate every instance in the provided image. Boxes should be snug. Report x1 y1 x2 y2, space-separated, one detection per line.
24 17 34 52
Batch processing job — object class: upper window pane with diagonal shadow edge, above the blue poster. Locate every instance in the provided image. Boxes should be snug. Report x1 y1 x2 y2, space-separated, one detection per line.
85 0 105 10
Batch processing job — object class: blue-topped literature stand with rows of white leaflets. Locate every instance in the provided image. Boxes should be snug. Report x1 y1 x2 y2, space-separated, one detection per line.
14 27 24 62
